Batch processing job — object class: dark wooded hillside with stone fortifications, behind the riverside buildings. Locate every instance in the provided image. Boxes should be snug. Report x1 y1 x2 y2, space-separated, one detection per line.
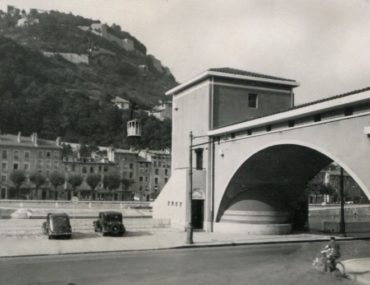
0 8 176 148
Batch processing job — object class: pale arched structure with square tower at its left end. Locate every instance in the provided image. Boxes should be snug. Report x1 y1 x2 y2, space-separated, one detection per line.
153 68 370 234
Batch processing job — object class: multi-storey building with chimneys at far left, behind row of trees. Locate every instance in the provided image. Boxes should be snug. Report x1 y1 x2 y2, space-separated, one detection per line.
0 133 62 199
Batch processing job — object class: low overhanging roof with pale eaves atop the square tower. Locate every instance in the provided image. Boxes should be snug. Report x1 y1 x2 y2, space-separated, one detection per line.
166 67 299 95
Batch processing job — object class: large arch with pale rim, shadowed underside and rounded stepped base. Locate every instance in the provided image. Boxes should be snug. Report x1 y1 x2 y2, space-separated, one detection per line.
215 140 369 233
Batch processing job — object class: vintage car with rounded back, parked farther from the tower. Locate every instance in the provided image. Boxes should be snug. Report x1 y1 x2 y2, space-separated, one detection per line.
42 213 72 239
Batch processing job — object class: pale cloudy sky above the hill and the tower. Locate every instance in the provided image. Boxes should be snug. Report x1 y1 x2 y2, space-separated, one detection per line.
0 0 370 104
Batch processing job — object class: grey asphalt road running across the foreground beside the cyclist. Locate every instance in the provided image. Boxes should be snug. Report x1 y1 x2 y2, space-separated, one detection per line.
0 241 370 285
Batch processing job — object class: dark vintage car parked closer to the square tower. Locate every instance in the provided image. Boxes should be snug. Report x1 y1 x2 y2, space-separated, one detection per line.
93 211 126 236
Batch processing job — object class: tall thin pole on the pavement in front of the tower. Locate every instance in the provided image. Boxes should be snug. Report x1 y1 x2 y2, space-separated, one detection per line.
186 131 193 244
